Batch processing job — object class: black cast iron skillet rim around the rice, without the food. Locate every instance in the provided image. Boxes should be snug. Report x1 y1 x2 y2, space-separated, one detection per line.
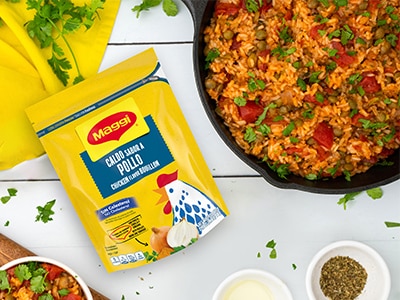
183 0 400 194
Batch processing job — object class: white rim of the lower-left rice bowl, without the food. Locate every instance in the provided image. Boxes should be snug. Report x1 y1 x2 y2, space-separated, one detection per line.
0 256 93 300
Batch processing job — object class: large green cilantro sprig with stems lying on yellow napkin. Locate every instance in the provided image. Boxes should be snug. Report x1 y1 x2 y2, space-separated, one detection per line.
26 0 105 86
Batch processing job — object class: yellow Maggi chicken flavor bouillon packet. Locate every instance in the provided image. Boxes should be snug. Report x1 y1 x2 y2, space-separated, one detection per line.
26 49 228 272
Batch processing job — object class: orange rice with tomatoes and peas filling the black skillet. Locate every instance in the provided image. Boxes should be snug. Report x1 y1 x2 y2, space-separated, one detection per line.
204 0 400 180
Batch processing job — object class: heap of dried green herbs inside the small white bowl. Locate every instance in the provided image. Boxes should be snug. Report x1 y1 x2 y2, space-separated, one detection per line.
319 256 368 300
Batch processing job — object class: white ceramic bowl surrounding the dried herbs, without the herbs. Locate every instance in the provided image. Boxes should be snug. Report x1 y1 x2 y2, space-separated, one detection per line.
306 241 391 300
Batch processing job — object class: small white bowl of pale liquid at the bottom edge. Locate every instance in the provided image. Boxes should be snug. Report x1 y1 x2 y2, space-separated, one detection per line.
212 269 293 300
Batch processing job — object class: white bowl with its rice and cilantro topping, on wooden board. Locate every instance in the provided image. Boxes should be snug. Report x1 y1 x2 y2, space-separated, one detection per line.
0 256 93 300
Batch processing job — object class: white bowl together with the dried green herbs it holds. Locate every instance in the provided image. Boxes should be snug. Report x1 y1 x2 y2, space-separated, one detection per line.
306 241 391 300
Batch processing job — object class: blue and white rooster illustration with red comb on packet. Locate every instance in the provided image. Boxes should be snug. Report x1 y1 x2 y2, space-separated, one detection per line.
155 171 226 237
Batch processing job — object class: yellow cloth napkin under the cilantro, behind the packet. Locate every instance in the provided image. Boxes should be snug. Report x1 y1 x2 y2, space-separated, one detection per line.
0 0 120 170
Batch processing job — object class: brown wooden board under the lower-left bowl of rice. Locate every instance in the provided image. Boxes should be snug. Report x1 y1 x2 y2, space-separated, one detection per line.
0 233 109 300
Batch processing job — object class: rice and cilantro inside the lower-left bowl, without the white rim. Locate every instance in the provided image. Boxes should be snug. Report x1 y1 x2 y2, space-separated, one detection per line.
0 261 86 300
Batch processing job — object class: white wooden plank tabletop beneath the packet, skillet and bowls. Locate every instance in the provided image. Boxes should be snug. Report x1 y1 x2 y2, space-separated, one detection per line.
0 0 400 300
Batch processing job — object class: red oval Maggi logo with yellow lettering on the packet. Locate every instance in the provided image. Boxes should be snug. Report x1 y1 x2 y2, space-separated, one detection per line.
87 111 137 145
